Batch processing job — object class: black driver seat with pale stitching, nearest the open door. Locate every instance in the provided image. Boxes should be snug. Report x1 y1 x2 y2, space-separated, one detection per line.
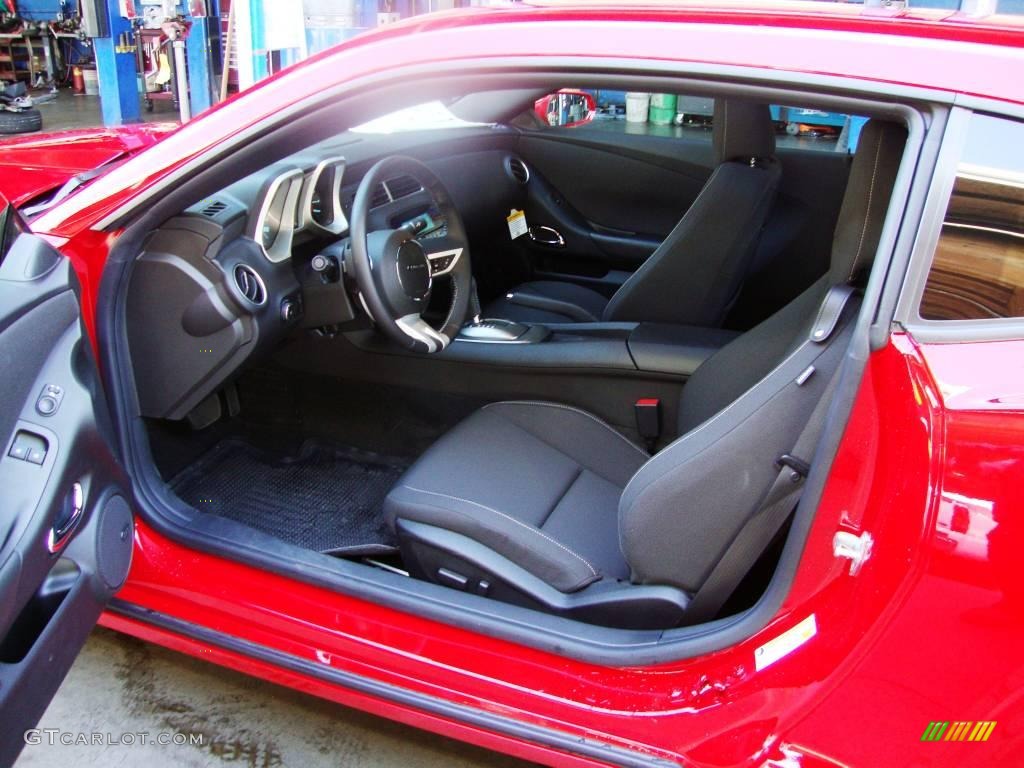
385 121 906 629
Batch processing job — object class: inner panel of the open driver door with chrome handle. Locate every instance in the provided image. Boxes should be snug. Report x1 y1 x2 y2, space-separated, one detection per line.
0 204 133 766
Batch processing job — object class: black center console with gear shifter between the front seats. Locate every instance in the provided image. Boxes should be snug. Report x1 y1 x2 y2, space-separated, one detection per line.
274 319 736 444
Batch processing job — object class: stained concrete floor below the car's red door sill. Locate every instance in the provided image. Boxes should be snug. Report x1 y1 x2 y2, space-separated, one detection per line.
15 629 529 768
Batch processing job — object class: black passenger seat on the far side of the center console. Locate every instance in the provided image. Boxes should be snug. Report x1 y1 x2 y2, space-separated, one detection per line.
483 98 780 327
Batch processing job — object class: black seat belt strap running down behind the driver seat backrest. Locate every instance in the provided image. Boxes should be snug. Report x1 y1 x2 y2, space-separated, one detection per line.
685 360 843 625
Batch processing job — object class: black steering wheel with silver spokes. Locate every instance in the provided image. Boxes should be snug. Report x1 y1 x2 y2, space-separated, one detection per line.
349 155 472 352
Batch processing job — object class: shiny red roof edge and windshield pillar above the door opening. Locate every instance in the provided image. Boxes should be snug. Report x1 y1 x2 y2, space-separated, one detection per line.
34 0 1024 236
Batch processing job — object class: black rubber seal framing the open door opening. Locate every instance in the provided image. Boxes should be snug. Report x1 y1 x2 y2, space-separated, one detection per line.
97 63 929 666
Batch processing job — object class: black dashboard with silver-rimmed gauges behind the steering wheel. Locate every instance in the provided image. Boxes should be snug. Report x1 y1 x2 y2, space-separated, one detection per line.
126 131 528 420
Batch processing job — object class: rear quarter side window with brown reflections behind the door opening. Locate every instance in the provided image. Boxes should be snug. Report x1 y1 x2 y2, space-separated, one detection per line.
920 115 1024 321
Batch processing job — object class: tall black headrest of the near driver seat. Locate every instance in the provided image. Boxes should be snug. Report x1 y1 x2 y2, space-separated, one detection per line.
828 120 906 285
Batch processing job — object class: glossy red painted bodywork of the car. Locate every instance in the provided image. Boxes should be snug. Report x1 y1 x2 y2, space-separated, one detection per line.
0 6 1024 768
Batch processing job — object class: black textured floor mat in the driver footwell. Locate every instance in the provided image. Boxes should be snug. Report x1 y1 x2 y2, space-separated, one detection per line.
170 439 407 556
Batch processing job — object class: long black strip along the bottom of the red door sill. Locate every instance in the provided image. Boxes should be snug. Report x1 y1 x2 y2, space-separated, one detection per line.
108 599 680 768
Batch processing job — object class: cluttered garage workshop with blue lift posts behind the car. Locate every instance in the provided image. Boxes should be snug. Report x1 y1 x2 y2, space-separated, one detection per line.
0 0 1024 130
